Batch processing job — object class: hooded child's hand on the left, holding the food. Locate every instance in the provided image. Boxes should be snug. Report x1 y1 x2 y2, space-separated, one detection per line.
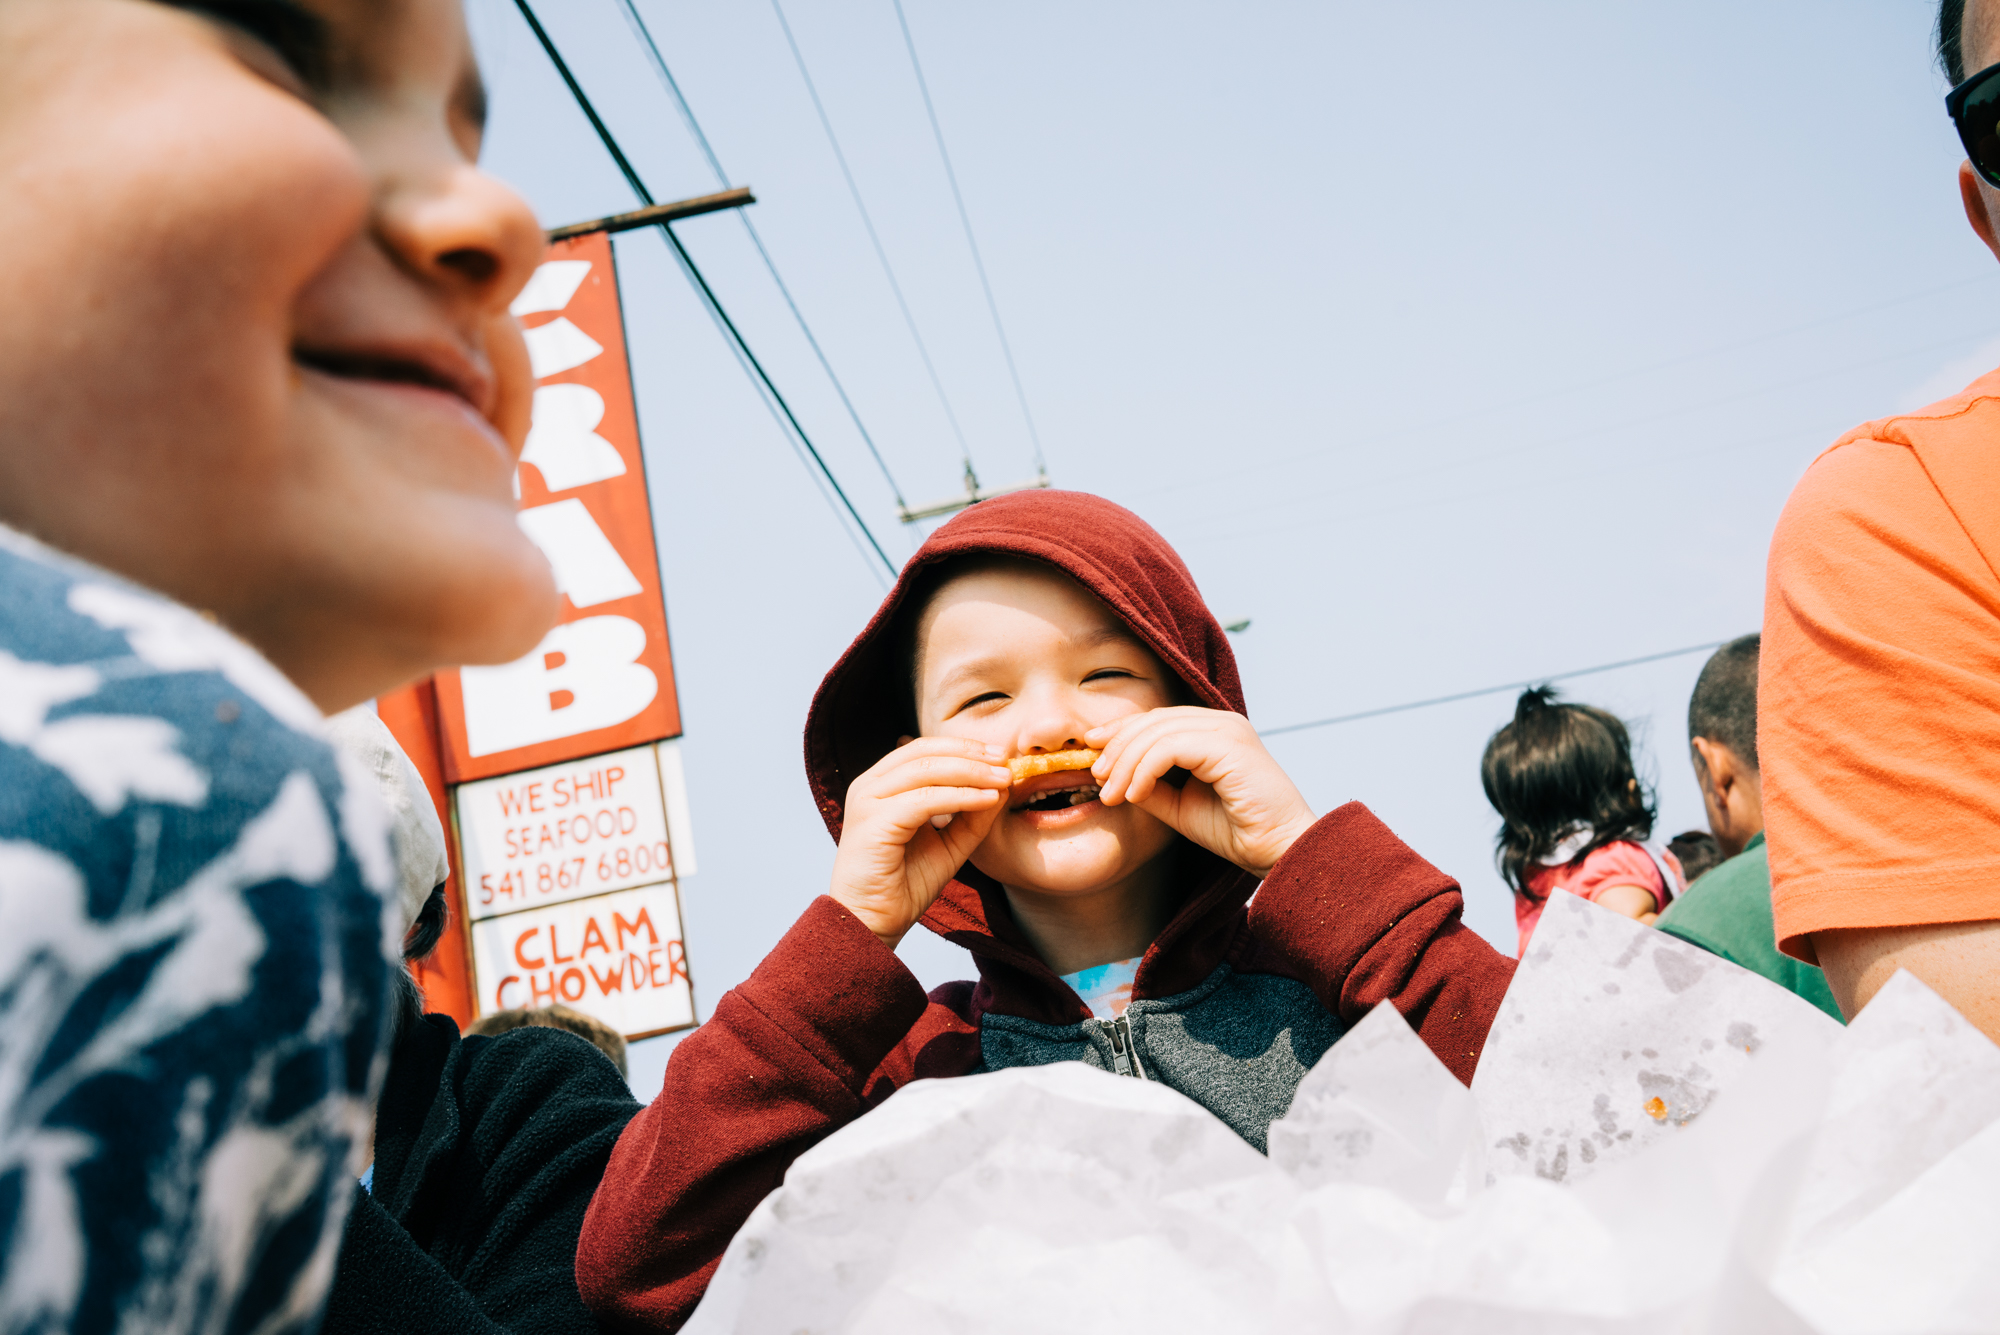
826 737 1014 949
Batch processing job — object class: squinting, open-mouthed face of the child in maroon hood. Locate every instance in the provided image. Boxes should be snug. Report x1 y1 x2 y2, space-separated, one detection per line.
916 562 1176 895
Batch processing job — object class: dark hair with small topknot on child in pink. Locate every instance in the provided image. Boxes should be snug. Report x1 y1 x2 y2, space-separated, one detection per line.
1480 685 1656 899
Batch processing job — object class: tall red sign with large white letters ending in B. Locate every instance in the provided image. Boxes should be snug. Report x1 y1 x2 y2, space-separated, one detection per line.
436 232 680 783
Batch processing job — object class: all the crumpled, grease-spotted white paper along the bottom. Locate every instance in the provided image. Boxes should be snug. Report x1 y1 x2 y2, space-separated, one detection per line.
686 895 2000 1335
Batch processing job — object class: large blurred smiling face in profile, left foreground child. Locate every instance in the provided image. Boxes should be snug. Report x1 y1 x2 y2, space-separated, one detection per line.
0 0 558 709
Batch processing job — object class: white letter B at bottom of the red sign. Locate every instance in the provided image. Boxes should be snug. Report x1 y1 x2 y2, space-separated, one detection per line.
458 616 660 755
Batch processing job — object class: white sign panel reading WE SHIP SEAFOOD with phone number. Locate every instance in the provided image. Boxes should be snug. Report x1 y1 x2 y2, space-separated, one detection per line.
458 745 674 923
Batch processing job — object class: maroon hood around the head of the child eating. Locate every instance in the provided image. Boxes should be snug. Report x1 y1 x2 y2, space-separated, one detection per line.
806 490 1254 1015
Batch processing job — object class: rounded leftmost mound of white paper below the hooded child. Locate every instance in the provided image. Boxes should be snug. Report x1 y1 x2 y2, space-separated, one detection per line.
686 1061 1338 1335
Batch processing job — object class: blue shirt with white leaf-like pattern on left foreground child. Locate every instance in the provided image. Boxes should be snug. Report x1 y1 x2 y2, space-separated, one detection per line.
0 528 400 1335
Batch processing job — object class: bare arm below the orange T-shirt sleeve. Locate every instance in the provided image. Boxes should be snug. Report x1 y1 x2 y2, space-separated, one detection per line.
1812 921 2000 1043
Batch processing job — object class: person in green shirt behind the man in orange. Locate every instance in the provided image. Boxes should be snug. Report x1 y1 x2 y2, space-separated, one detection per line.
1656 636 1846 1023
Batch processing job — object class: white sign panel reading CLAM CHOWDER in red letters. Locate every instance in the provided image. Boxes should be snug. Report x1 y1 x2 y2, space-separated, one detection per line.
472 885 694 1039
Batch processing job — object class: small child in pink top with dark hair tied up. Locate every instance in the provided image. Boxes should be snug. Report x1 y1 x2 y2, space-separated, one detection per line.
1480 685 1684 953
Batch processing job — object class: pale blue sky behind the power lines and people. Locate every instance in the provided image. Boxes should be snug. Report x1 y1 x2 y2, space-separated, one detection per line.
472 0 2000 1095
